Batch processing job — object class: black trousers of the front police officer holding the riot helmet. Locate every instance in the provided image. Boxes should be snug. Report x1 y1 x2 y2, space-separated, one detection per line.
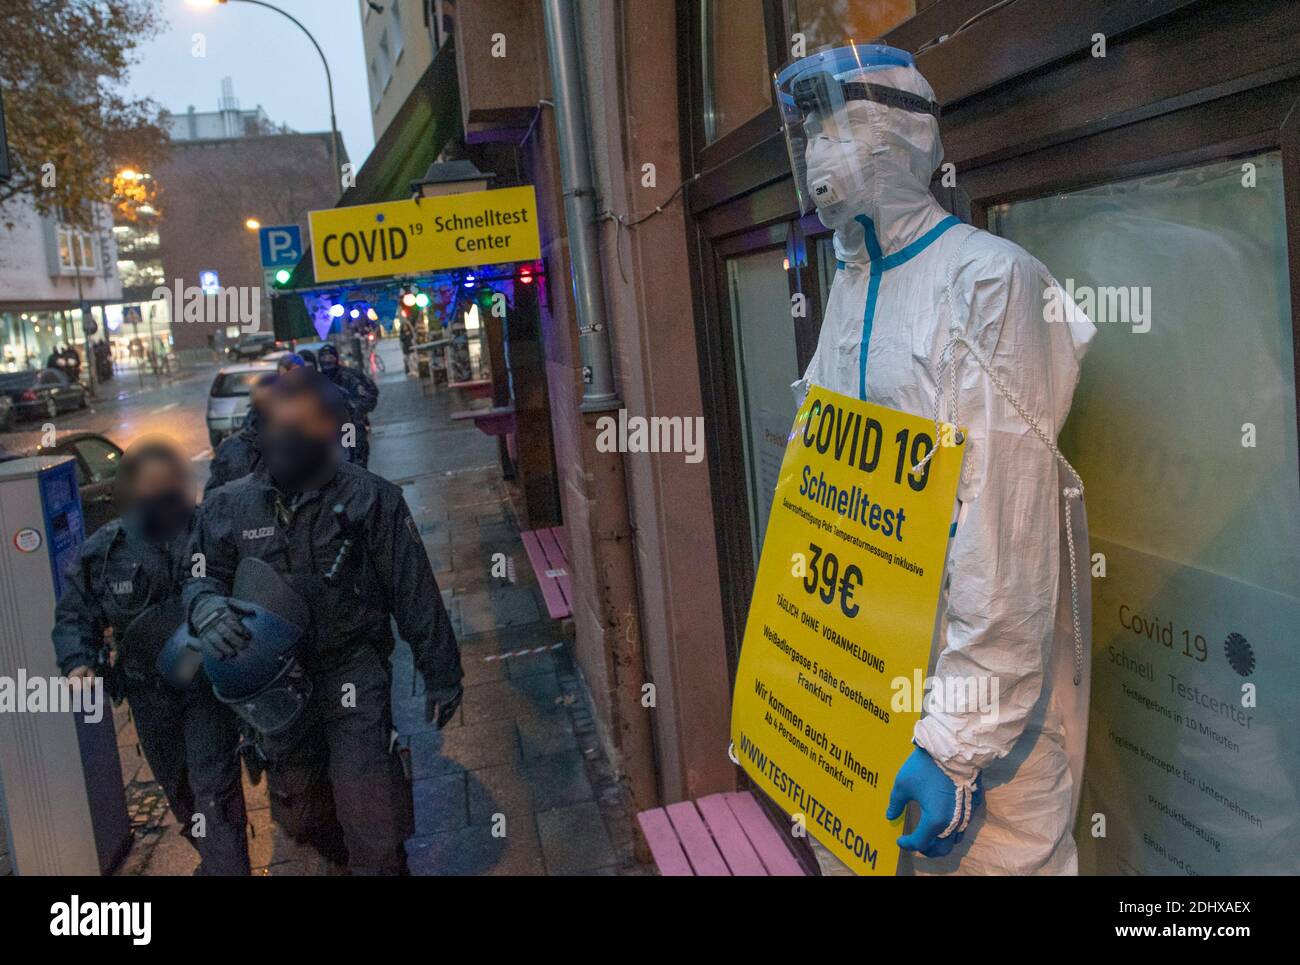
261 648 415 875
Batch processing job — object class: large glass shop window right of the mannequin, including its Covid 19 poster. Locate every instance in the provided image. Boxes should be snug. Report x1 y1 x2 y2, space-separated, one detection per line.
991 151 1300 874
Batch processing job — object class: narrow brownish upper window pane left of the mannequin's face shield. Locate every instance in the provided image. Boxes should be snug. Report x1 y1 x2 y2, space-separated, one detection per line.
701 0 772 144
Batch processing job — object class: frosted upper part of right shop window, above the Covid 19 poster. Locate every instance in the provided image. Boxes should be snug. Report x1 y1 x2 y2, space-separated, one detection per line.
989 152 1300 600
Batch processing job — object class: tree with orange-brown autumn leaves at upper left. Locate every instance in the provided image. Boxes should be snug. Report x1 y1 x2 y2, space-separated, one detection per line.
0 0 168 226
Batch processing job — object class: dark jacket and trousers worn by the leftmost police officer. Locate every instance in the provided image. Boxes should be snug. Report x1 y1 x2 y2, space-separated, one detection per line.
52 519 248 875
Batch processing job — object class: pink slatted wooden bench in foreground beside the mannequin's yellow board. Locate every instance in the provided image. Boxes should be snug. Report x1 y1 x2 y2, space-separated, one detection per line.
637 791 807 878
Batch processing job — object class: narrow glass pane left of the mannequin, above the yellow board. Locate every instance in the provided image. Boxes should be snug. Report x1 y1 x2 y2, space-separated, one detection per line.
727 248 800 562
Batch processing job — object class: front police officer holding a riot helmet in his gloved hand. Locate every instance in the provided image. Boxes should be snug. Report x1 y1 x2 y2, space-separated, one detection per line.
183 369 462 874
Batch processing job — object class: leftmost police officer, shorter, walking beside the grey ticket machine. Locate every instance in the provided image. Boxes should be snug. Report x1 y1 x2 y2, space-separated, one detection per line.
53 441 248 875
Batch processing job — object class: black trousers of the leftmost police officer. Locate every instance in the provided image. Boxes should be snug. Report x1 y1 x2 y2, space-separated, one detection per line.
126 681 250 875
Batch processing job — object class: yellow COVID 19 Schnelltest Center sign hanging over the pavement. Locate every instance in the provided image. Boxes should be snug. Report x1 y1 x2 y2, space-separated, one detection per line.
308 185 542 281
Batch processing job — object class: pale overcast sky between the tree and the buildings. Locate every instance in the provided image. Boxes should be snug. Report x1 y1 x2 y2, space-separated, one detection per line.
129 0 374 166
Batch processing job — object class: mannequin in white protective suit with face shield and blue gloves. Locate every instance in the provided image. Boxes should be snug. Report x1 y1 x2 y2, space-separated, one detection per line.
777 46 1095 874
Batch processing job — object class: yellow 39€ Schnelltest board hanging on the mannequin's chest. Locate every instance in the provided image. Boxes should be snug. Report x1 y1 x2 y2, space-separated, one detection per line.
731 386 963 874
